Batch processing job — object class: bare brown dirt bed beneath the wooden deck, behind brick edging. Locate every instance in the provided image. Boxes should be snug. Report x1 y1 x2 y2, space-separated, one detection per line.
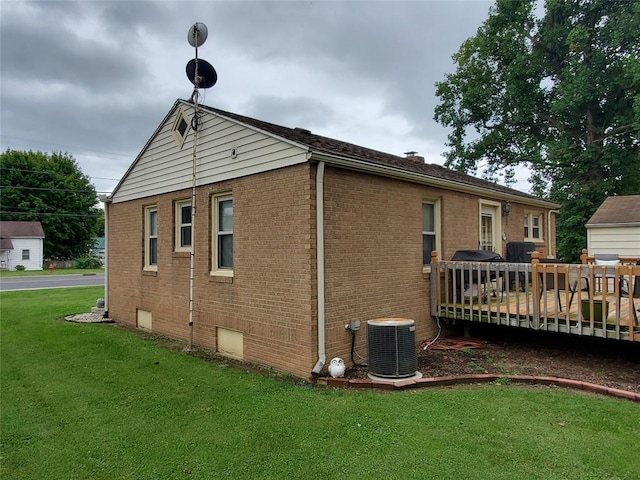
348 325 640 393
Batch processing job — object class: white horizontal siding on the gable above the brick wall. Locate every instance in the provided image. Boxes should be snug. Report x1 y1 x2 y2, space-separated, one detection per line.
113 104 307 203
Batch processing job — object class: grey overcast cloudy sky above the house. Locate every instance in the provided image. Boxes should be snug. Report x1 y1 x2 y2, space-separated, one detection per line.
0 0 526 197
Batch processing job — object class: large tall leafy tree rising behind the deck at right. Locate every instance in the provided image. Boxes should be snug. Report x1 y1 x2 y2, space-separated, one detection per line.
434 0 640 261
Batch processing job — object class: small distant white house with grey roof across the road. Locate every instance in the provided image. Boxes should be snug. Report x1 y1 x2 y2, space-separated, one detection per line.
0 221 44 270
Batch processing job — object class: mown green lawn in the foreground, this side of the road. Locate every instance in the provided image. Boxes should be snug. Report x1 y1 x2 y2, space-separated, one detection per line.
0 287 640 480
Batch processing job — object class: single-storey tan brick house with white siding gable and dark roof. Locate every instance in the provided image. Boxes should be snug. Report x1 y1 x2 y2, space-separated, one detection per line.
104 100 557 377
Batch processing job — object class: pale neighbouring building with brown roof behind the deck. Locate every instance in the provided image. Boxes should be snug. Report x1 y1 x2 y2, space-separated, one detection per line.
586 195 640 259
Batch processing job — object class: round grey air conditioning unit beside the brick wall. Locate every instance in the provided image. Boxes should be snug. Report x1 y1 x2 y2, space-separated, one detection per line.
367 318 418 378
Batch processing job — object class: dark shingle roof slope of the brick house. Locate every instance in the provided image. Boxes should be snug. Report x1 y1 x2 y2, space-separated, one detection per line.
198 100 553 205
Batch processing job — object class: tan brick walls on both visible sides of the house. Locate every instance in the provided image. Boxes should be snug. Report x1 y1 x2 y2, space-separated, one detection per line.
109 164 546 377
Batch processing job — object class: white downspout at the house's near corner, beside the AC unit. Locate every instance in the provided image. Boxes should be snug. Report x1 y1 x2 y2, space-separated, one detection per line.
311 162 327 376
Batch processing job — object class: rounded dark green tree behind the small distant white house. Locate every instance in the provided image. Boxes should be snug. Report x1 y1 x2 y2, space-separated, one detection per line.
0 150 99 259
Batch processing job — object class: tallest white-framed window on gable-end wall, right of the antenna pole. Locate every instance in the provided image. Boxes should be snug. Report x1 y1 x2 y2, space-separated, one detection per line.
212 195 233 275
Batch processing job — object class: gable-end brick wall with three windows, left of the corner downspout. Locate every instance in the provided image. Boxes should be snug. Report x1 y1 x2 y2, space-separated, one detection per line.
109 164 317 376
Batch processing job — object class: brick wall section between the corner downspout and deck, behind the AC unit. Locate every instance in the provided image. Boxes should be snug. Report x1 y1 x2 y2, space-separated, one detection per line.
324 168 436 364
